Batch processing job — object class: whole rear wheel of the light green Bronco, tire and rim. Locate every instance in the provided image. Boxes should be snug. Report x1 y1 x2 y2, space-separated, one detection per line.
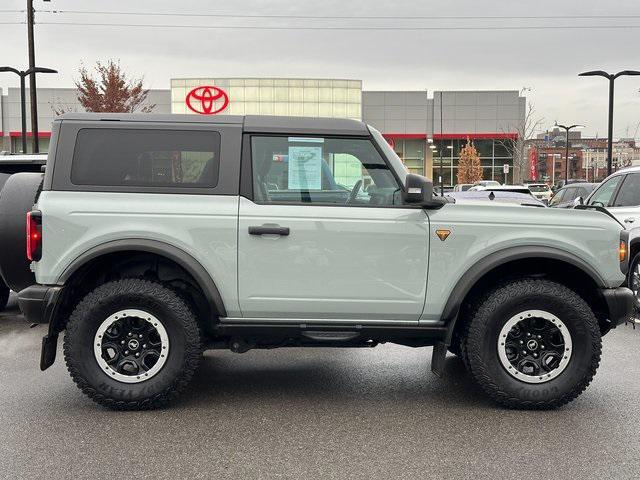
64 279 202 410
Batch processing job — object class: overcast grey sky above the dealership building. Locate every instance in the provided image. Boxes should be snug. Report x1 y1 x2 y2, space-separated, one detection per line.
0 0 640 137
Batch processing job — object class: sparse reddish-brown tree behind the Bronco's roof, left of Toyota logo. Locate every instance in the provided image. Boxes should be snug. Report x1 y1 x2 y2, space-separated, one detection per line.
54 60 155 114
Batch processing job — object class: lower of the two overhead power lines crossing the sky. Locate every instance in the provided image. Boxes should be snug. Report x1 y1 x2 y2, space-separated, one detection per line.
33 22 640 31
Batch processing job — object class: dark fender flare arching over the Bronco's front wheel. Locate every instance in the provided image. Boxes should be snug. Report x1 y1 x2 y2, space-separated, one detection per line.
441 245 605 343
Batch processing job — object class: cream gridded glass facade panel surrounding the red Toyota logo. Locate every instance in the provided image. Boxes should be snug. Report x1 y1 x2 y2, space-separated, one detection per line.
171 78 362 120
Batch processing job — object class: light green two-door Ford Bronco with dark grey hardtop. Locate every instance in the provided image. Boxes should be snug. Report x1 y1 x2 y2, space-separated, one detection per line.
2 114 637 409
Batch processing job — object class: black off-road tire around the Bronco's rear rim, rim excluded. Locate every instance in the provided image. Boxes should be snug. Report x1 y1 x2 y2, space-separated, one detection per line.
64 279 203 410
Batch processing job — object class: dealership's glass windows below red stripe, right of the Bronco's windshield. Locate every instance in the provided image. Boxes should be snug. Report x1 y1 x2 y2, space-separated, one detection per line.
427 139 513 186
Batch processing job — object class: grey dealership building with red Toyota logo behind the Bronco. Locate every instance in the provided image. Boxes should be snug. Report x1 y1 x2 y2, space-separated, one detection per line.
0 77 526 185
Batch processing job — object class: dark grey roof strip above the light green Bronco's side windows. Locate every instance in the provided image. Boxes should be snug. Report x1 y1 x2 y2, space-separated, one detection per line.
56 113 370 136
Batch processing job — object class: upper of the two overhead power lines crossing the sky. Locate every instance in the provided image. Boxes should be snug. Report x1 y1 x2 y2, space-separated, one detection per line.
38 10 640 20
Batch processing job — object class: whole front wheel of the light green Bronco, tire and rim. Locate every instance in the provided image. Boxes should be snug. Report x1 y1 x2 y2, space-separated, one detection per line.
464 279 601 409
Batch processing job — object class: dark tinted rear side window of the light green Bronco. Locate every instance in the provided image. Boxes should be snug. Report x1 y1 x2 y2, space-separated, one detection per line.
71 128 220 188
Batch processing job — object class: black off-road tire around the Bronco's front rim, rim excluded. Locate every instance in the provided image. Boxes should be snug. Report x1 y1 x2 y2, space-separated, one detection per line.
463 279 602 410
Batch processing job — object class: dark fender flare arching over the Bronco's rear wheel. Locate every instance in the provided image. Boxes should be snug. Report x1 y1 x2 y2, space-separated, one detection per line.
59 238 227 317
